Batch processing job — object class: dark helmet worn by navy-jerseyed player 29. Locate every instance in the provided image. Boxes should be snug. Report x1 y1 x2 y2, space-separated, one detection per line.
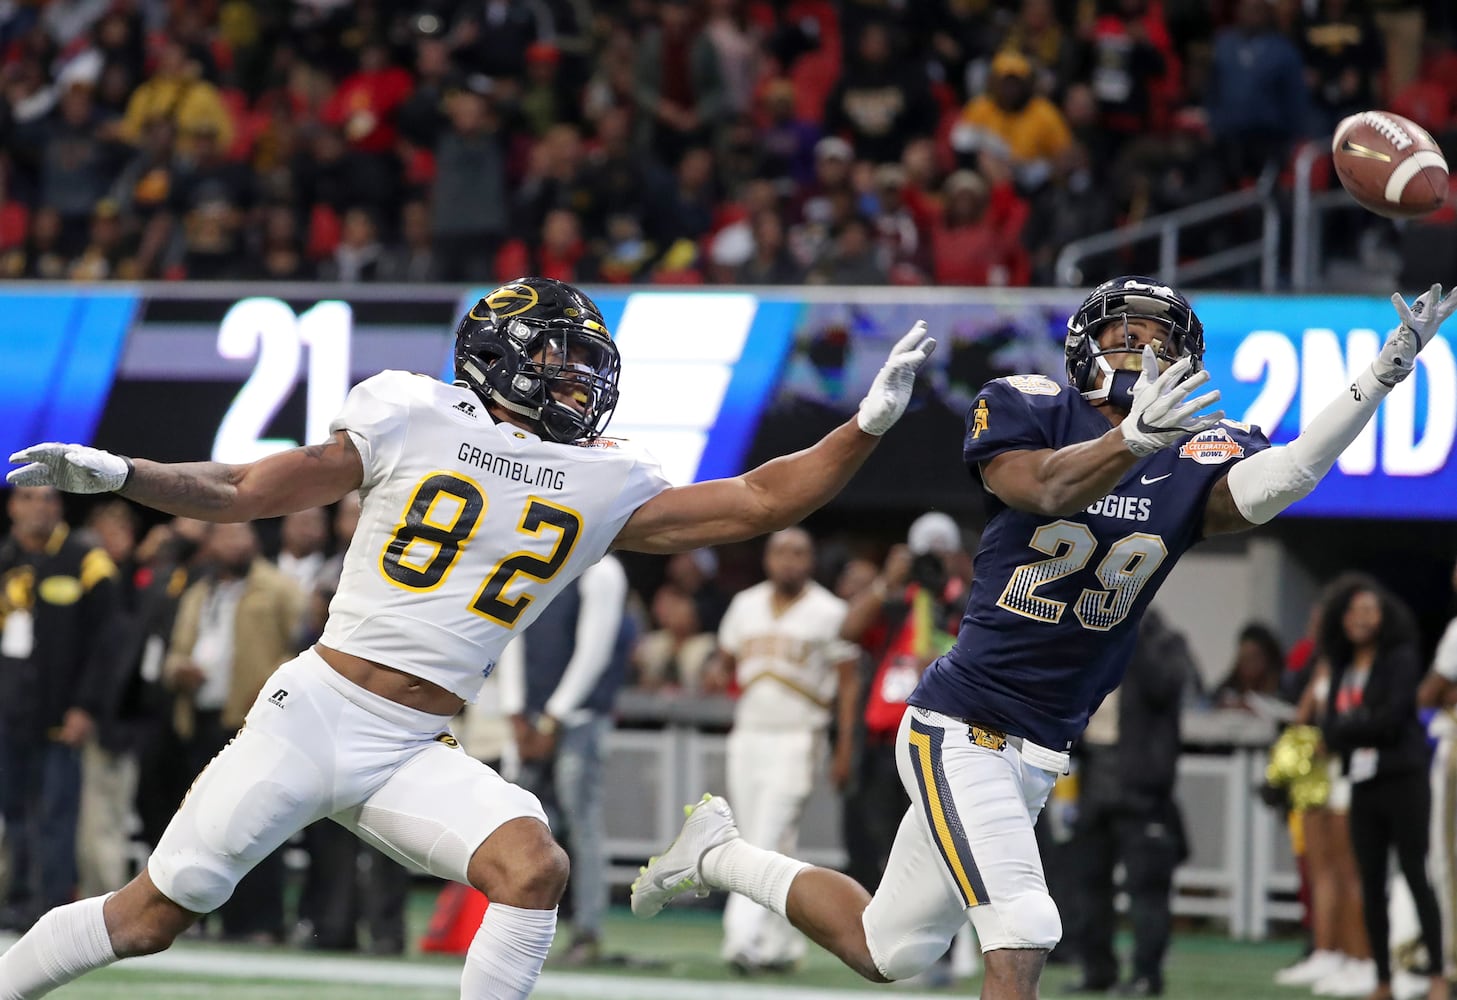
1064 274 1203 410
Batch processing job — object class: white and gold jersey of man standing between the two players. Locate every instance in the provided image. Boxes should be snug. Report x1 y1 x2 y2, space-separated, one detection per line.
718 580 857 730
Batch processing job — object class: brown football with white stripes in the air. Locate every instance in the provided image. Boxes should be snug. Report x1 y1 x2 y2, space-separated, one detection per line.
1330 111 1447 219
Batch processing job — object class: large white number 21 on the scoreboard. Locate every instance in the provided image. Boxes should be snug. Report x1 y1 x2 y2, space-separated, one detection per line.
213 297 354 464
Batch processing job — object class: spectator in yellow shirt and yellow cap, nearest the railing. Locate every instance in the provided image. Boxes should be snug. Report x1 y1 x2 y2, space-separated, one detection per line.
951 51 1072 190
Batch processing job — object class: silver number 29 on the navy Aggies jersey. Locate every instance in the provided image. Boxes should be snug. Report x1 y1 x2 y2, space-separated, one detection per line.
997 520 1169 631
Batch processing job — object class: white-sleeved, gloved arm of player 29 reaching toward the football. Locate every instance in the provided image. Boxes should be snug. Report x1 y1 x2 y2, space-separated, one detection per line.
1203 284 1457 536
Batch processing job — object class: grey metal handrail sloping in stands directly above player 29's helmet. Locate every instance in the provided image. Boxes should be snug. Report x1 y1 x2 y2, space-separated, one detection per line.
1055 169 1279 292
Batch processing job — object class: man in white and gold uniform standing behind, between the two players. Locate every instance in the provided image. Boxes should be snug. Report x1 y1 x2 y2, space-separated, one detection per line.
710 528 860 974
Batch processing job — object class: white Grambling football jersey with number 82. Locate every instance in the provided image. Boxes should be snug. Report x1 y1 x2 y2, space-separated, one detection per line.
319 372 669 701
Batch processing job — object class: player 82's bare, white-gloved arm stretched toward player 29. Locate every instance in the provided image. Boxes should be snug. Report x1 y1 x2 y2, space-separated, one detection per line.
613 322 935 552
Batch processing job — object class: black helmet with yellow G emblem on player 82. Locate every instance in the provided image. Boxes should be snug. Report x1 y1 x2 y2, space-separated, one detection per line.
455 277 622 443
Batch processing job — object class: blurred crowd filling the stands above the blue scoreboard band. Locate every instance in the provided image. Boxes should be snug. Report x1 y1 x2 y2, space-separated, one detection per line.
0 0 1457 286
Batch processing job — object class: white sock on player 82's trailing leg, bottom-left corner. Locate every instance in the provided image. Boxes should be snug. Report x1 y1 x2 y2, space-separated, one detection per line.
0 892 117 1000
